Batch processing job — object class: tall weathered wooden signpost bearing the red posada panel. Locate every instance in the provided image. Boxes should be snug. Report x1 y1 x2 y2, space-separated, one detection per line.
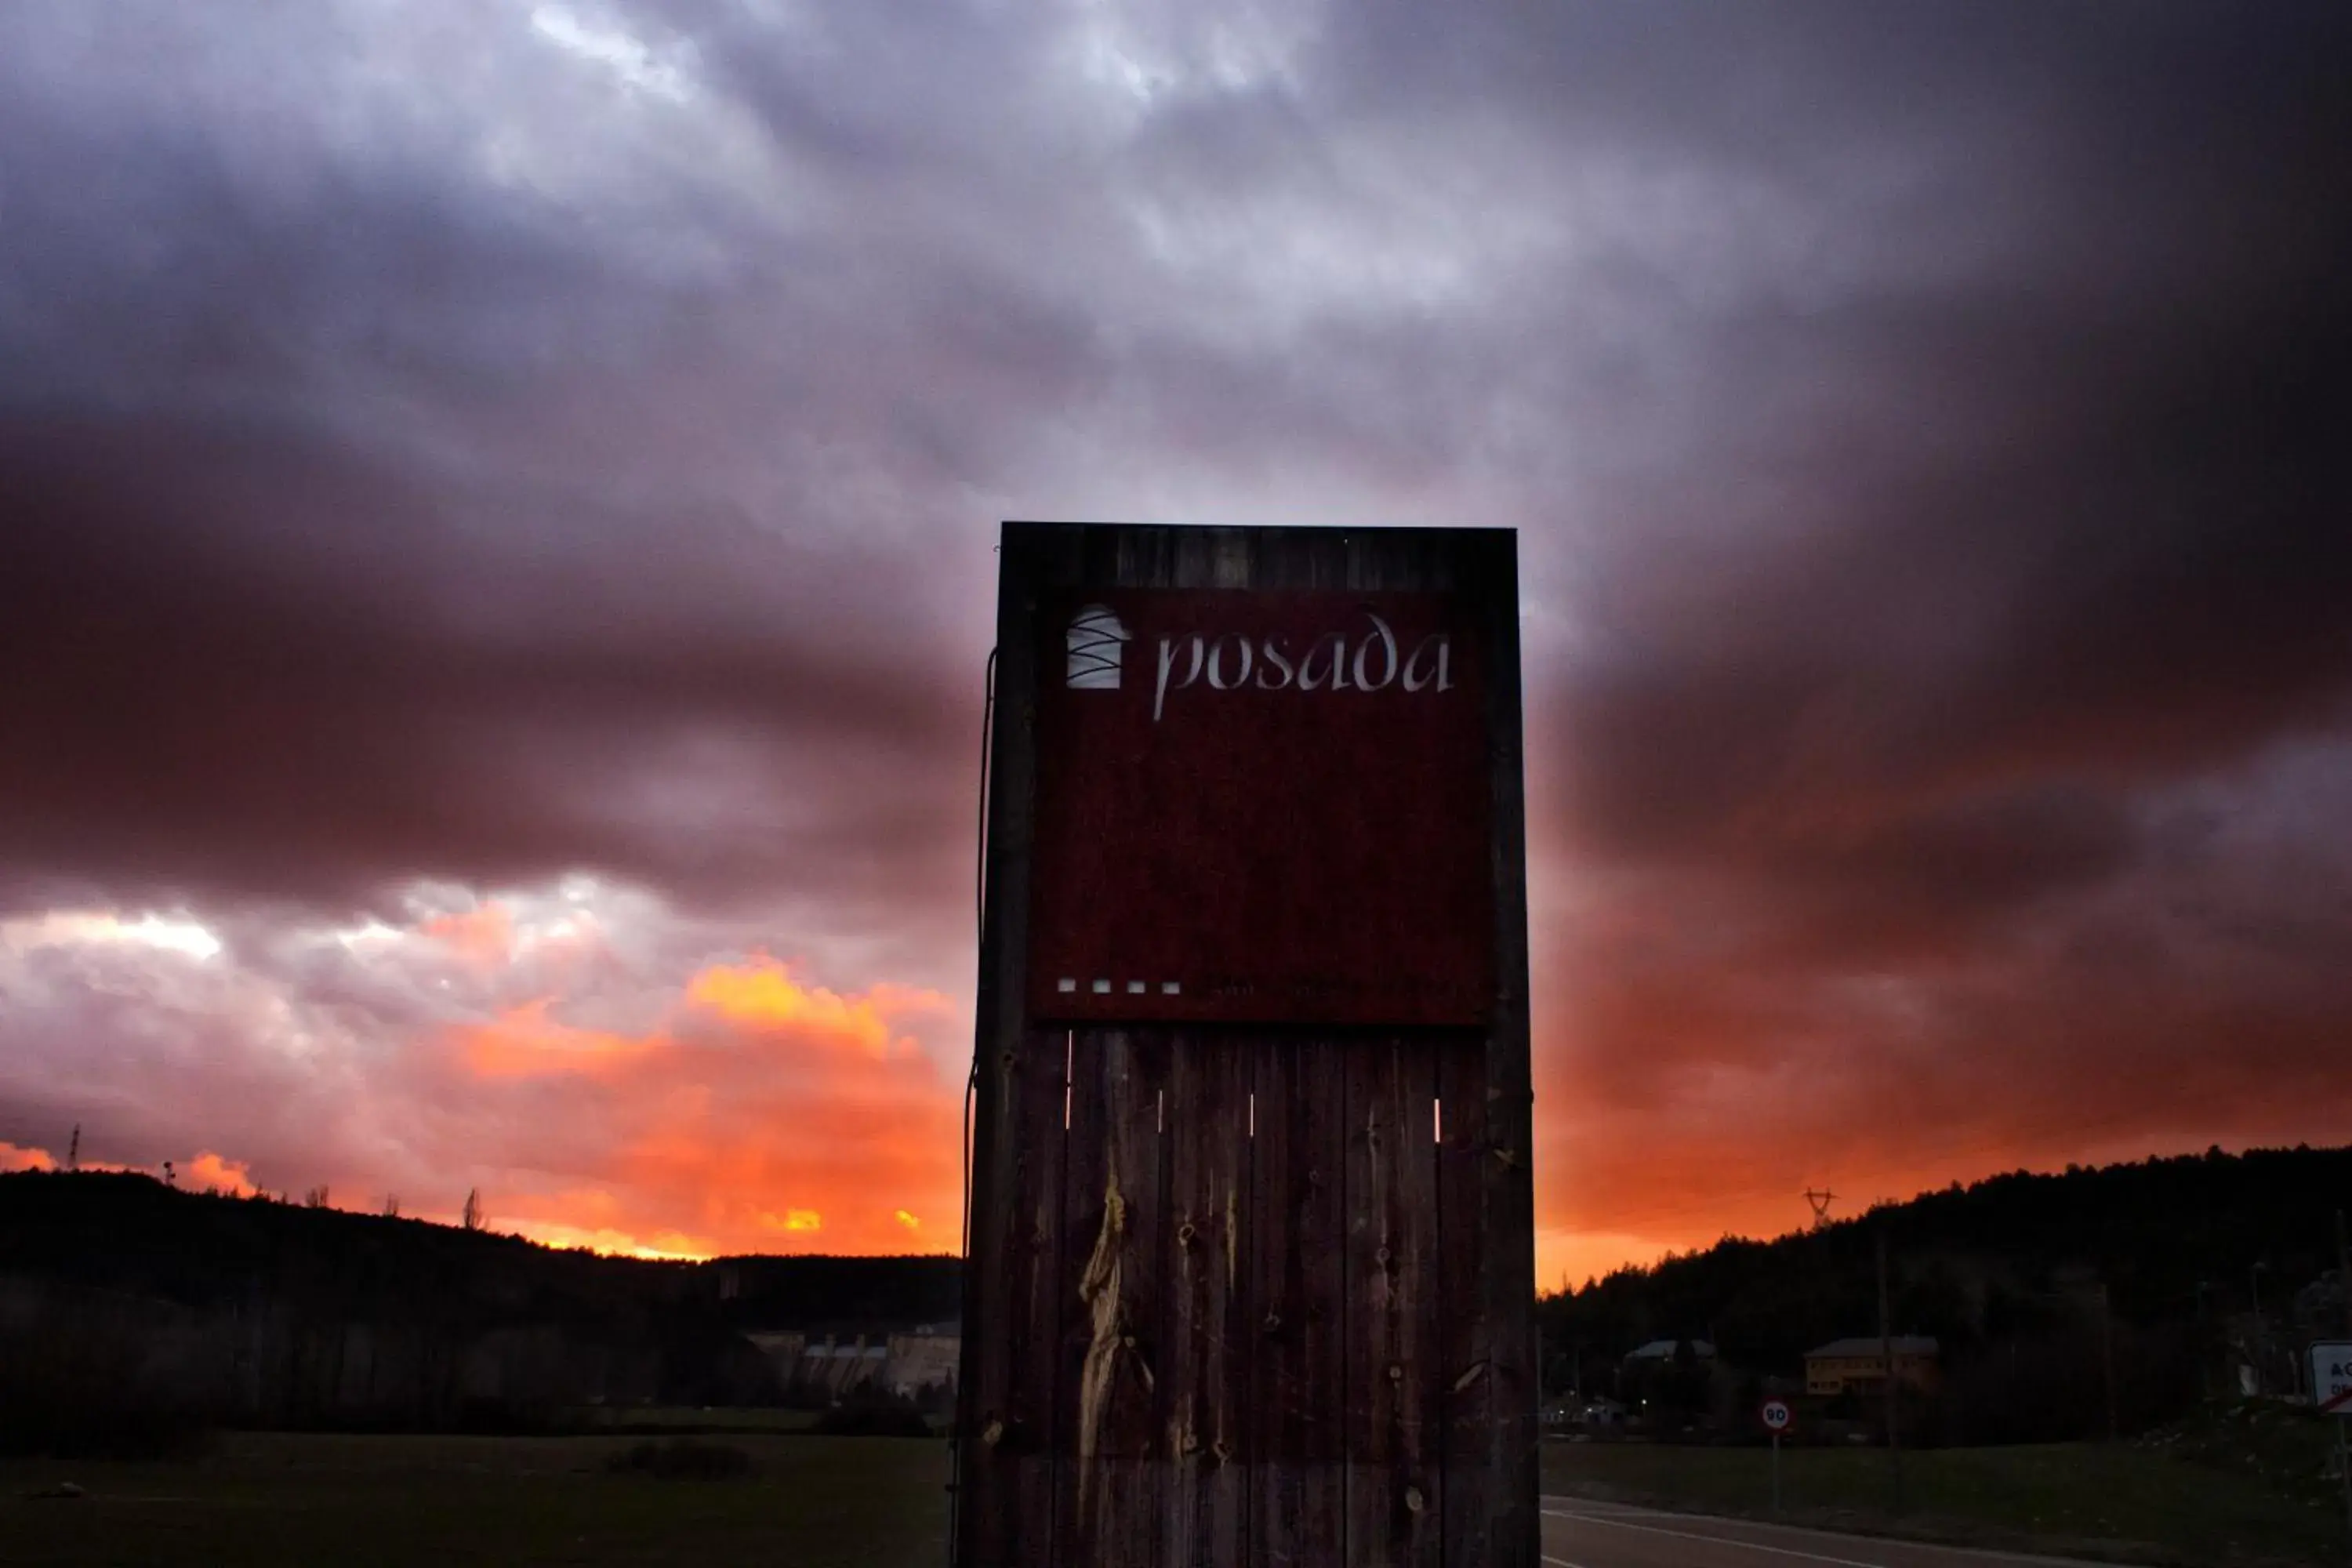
955 522 1538 1568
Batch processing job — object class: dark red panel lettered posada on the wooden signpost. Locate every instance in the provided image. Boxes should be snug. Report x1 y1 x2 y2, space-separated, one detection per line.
1030 590 1494 1025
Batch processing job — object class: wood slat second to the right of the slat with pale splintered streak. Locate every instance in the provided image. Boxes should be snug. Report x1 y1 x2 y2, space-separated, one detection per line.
1242 1036 1348 1568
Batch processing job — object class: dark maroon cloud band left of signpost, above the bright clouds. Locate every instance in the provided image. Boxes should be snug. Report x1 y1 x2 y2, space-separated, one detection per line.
0 419 967 921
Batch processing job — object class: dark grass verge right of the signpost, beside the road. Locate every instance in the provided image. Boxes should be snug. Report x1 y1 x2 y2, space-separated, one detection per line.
1543 1443 2347 1568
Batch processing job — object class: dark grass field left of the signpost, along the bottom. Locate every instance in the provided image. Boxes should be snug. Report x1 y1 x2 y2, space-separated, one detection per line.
0 1434 948 1568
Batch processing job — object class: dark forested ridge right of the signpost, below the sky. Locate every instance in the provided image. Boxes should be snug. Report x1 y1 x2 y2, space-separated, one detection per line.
1538 1147 2352 1436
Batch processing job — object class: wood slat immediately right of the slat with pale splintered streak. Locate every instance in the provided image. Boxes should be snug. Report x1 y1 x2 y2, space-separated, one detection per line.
1160 1029 1256 1568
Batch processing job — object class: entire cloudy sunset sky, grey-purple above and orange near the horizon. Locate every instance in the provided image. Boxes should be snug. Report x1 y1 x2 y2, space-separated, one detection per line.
0 0 2352 1286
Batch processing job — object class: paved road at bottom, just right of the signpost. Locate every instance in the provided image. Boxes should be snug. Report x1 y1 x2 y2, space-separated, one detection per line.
1543 1497 2089 1568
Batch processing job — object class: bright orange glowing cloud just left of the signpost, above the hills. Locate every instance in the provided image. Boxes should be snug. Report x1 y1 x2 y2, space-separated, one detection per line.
437 956 962 1255
